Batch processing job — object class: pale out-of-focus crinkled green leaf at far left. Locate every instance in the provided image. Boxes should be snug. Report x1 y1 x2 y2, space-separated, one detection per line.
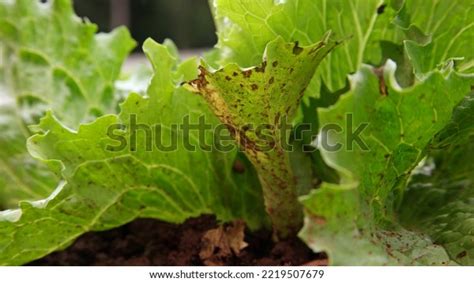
0 0 135 207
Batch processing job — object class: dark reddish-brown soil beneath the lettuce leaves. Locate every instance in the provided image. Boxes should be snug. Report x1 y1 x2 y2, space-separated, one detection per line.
30 216 326 266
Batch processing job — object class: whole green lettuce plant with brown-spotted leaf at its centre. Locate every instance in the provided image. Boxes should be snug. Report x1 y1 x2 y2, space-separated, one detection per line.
0 0 474 265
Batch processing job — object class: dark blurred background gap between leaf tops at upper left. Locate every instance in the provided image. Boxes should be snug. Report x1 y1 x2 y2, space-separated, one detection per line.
74 0 217 51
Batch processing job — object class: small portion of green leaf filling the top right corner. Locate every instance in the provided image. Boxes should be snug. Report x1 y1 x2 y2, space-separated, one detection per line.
396 0 474 78
